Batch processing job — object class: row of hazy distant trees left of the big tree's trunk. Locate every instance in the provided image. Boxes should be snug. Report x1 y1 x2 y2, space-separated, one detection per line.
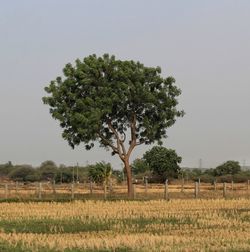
0 160 123 183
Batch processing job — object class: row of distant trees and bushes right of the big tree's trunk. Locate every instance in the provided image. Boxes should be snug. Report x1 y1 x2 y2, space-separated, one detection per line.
132 150 250 183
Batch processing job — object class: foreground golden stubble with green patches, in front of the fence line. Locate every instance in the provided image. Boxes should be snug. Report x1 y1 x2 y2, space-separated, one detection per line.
0 198 250 251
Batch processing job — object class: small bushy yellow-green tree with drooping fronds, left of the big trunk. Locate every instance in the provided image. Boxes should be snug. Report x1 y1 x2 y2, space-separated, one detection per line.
89 162 112 184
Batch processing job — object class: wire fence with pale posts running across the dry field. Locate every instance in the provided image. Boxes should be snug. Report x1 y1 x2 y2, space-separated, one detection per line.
0 180 250 200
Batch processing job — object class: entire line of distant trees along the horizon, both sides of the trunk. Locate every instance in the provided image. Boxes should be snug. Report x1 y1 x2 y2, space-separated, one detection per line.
0 146 250 184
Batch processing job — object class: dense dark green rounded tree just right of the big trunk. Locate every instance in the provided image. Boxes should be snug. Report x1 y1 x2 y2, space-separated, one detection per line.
143 146 182 181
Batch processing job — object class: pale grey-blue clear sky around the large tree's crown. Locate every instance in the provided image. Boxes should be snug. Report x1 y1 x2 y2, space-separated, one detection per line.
0 0 250 168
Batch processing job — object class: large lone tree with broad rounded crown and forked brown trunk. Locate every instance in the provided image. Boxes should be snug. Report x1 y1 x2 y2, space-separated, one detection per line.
43 54 184 196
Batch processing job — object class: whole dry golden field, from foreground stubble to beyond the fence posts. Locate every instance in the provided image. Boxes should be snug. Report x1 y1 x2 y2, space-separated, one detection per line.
0 183 250 252
